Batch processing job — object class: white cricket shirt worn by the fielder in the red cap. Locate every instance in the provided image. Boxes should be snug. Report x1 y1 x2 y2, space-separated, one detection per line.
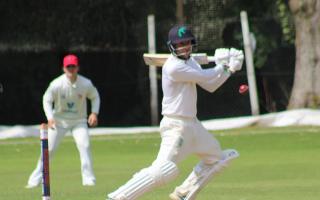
43 74 100 127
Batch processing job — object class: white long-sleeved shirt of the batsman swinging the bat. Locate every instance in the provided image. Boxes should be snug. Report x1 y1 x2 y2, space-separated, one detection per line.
162 55 230 118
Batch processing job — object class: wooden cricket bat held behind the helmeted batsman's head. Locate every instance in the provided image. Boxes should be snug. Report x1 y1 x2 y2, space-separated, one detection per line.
143 53 215 67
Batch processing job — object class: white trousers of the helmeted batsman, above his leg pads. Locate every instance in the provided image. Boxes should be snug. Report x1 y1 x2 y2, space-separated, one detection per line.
156 116 222 165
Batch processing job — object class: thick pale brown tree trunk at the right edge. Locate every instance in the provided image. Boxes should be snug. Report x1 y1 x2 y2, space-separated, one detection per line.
288 0 320 109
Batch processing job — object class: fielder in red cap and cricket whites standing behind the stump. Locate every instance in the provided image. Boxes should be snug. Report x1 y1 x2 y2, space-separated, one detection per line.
26 54 100 188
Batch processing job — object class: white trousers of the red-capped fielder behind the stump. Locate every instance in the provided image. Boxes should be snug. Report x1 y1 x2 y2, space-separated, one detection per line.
28 123 96 185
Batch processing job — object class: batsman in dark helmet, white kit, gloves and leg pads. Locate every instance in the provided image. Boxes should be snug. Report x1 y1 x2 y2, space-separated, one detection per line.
108 25 244 200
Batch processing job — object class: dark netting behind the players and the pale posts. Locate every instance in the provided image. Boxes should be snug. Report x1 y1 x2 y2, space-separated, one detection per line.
0 0 295 126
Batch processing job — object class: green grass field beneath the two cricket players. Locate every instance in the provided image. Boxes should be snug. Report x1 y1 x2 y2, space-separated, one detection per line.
0 127 320 200
